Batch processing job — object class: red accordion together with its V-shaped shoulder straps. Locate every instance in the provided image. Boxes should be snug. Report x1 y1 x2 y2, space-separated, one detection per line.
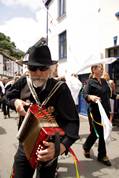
17 78 65 168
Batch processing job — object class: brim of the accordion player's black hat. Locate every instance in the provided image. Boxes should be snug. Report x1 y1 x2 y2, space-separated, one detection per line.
22 61 58 66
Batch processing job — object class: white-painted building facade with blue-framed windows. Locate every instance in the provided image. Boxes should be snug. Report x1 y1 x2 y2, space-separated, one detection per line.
45 0 119 113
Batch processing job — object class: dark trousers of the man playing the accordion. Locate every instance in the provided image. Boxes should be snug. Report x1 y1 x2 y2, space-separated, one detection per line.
13 144 57 178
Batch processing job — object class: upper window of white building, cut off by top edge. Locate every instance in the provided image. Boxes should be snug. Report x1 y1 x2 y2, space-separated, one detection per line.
59 0 66 17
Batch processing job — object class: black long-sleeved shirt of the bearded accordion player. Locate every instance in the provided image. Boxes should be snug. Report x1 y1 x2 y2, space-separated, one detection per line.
6 77 79 148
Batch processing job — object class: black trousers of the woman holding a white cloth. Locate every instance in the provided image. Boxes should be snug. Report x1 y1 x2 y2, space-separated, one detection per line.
83 114 106 158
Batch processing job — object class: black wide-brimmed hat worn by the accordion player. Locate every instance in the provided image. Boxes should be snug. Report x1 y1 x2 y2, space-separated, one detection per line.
23 45 57 66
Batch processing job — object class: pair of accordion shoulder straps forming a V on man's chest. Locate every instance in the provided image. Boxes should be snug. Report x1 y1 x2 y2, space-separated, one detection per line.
26 76 64 106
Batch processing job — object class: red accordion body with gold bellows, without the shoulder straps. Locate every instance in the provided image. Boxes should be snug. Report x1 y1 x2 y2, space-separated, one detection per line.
17 104 64 168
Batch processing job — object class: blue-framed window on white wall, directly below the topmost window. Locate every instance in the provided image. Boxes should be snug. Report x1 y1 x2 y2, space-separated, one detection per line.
59 31 67 60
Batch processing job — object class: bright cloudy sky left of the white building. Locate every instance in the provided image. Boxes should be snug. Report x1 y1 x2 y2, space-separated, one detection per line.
0 0 46 52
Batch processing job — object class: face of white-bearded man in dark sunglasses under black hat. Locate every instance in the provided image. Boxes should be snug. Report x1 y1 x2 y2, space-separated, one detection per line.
28 66 50 87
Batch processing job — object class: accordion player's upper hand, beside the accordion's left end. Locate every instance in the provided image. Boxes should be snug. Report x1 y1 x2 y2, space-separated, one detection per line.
14 99 29 116
